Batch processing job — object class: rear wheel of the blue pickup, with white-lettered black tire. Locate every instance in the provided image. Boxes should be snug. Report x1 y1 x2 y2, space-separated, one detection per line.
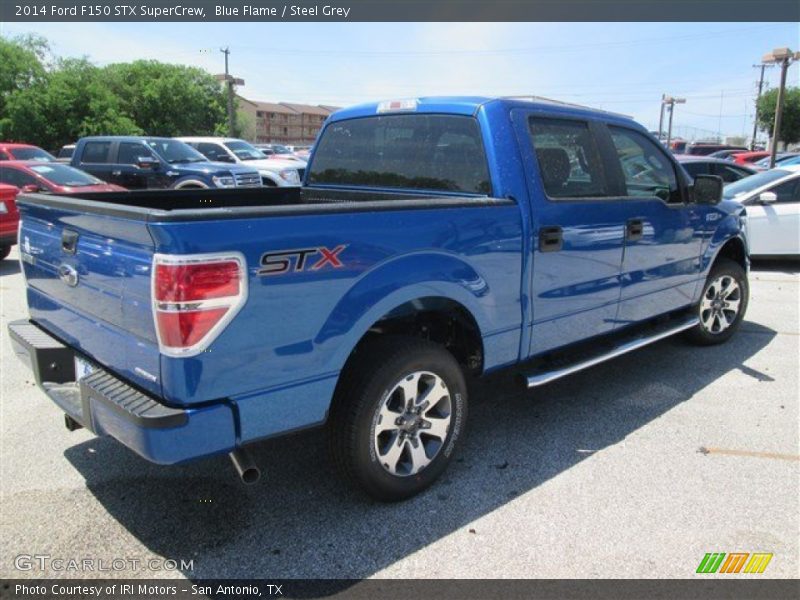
328 336 467 502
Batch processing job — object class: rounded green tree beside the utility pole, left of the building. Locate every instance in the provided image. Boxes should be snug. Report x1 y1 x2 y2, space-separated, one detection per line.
104 60 225 137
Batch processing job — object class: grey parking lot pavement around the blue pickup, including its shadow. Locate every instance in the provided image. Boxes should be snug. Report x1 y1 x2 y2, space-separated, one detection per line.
0 249 800 578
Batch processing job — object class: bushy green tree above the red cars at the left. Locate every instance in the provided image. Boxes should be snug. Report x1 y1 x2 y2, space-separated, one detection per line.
2 59 142 150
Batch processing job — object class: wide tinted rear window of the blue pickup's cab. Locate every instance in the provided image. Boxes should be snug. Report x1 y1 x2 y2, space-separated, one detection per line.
308 114 491 195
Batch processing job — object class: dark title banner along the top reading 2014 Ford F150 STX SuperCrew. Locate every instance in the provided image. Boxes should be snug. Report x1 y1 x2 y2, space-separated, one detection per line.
0 0 800 23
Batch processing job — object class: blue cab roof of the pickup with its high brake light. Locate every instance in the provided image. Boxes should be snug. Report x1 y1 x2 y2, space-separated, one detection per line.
330 96 631 121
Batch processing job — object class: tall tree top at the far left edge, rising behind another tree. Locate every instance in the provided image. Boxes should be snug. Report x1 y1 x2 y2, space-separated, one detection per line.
0 35 49 117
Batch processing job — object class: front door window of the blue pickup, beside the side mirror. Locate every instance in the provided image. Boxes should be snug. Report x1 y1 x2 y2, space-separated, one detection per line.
608 126 683 202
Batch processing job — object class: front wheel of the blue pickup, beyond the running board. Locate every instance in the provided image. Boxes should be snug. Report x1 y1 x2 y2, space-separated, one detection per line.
686 258 750 346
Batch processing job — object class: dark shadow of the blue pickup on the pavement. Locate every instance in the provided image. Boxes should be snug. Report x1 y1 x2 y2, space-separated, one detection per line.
65 322 775 579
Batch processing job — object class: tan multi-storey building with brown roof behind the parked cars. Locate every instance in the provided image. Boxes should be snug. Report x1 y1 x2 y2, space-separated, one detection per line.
238 96 338 146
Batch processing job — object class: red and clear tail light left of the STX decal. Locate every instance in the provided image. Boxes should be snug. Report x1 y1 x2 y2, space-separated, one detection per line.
152 253 247 356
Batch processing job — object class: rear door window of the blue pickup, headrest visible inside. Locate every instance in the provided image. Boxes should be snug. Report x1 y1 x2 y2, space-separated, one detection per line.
529 117 608 199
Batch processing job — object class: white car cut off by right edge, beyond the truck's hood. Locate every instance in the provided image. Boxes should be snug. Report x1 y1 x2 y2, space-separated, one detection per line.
723 165 800 257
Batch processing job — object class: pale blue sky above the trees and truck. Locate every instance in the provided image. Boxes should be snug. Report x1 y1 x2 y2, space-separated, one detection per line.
0 23 800 139
